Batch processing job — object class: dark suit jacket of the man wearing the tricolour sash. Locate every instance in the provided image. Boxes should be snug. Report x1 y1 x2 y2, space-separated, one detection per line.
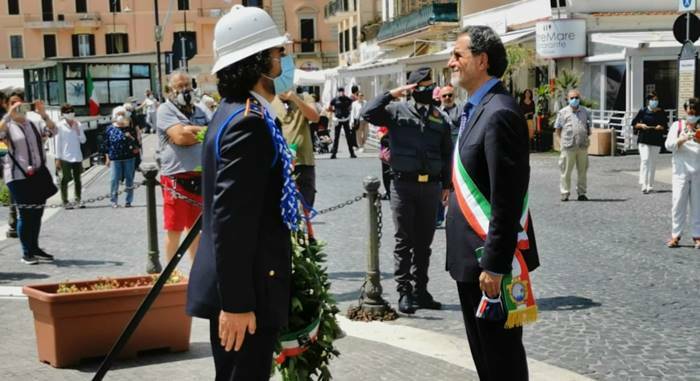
446 83 539 282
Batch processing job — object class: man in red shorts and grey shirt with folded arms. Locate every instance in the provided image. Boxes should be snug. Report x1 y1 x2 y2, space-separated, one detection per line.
157 72 209 272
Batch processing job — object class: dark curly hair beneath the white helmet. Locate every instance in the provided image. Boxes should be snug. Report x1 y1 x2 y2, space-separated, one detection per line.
216 49 272 103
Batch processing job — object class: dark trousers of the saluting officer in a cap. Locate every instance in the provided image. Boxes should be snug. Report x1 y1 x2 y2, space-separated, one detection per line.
390 179 442 294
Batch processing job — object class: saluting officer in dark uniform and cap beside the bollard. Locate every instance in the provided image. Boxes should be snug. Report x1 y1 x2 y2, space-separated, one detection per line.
362 67 452 314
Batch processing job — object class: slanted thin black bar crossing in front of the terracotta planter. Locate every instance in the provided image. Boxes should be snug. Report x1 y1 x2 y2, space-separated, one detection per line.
92 215 202 381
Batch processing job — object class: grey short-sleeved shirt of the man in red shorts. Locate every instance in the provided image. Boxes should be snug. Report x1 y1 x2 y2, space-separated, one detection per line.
157 101 208 176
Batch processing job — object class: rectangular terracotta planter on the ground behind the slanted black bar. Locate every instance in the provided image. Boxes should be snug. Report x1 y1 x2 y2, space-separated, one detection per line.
22 276 192 368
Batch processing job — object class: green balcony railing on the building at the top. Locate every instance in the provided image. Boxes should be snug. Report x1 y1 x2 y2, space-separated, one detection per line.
377 2 459 41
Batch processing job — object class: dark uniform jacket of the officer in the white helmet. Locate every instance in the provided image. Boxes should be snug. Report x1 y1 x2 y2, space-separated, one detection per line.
187 96 291 327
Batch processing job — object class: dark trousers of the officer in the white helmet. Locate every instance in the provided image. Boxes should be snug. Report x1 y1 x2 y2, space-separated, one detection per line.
209 318 278 381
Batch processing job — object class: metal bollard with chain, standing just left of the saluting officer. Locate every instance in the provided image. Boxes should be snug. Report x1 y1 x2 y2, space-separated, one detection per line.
360 176 389 314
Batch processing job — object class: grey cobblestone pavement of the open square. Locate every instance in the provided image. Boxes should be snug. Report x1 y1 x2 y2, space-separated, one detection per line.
0 134 700 381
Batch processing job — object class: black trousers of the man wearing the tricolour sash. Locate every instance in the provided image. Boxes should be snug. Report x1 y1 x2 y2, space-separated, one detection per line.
457 282 528 381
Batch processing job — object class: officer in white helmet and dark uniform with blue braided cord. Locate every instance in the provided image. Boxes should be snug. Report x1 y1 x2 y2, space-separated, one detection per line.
187 5 298 381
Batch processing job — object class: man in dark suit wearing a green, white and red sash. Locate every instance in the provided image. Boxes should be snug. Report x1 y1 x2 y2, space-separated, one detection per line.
447 26 539 381
